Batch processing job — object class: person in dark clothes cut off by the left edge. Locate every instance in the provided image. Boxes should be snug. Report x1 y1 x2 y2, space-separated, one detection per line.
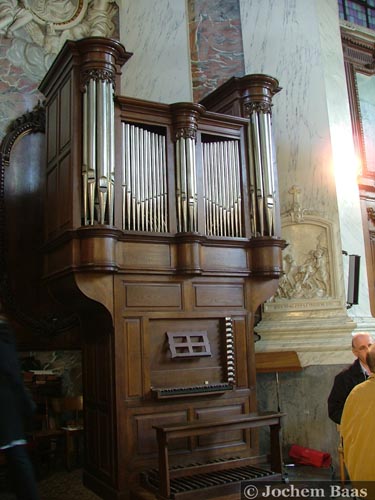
0 313 39 500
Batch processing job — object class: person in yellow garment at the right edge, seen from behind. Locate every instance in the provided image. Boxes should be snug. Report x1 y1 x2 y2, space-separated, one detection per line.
340 345 375 481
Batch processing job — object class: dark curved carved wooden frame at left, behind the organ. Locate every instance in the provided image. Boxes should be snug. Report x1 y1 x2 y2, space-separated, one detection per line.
0 104 78 336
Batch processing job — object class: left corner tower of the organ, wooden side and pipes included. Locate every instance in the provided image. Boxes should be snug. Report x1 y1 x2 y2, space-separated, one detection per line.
39 37 131 237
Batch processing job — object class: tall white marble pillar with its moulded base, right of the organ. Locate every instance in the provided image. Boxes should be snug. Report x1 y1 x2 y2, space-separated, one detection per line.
240 0 375 366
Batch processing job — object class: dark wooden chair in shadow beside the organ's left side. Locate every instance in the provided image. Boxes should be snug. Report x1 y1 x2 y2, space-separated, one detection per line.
50 395 84 470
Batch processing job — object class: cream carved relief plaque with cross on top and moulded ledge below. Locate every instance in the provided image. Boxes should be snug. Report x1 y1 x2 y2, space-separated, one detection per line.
255 185 356 366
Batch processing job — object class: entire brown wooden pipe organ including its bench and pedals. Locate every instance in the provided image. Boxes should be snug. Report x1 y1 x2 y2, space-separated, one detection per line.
40 38 285 499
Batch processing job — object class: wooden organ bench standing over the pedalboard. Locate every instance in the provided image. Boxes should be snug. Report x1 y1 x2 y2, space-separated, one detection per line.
144 412 284 500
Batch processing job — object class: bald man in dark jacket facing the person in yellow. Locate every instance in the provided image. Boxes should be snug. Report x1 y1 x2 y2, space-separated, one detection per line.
328 332 372 424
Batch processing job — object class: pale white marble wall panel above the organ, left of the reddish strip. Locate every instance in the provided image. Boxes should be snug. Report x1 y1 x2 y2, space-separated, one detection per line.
120 0 192 104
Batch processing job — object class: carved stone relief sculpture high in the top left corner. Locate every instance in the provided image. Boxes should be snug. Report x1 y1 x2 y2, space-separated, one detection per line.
0 0 118 81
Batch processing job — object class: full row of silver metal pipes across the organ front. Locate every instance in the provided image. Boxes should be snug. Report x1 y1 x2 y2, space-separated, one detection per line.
81 70 279 242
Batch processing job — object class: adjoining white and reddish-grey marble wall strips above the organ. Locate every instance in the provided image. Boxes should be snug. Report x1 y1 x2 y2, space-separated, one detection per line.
120 0 244 103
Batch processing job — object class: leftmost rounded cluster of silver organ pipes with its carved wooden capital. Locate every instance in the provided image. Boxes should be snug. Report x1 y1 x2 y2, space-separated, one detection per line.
78 41 131 226
